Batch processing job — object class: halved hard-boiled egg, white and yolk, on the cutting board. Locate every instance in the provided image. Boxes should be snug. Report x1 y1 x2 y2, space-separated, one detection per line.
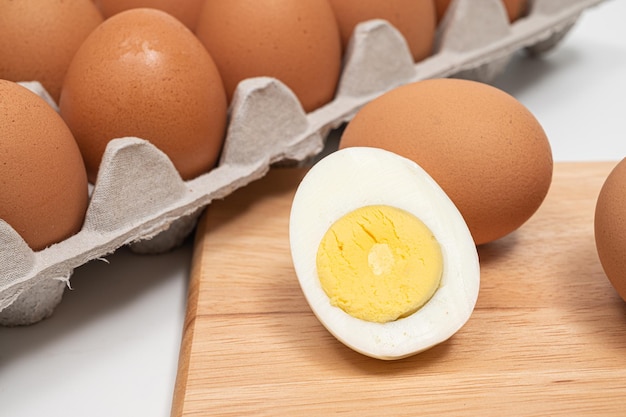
289 147 480 360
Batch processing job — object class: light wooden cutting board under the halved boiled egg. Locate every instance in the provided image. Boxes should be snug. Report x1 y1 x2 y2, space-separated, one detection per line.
172 162 626 416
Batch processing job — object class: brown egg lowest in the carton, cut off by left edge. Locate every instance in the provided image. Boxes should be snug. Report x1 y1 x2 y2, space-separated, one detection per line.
0 80 88 250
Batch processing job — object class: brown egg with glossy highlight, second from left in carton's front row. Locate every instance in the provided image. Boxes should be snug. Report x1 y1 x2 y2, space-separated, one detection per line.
59 9 227 182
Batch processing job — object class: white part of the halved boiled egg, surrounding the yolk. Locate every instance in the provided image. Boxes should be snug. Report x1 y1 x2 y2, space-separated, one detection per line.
289 147 480 359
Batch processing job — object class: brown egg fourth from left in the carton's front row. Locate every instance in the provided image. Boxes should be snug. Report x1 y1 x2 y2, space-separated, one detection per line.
330 0 436 61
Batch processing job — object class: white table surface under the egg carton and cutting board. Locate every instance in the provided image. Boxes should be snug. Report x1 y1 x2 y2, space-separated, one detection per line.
0 0 626 417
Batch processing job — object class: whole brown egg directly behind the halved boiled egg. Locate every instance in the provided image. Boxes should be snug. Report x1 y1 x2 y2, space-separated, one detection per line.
340 79 553 244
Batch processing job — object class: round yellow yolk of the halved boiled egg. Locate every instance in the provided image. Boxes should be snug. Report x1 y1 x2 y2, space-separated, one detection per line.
317 205 443 323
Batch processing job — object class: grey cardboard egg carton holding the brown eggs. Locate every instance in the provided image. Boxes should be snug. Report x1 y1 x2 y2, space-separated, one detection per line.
0 0 601 326
